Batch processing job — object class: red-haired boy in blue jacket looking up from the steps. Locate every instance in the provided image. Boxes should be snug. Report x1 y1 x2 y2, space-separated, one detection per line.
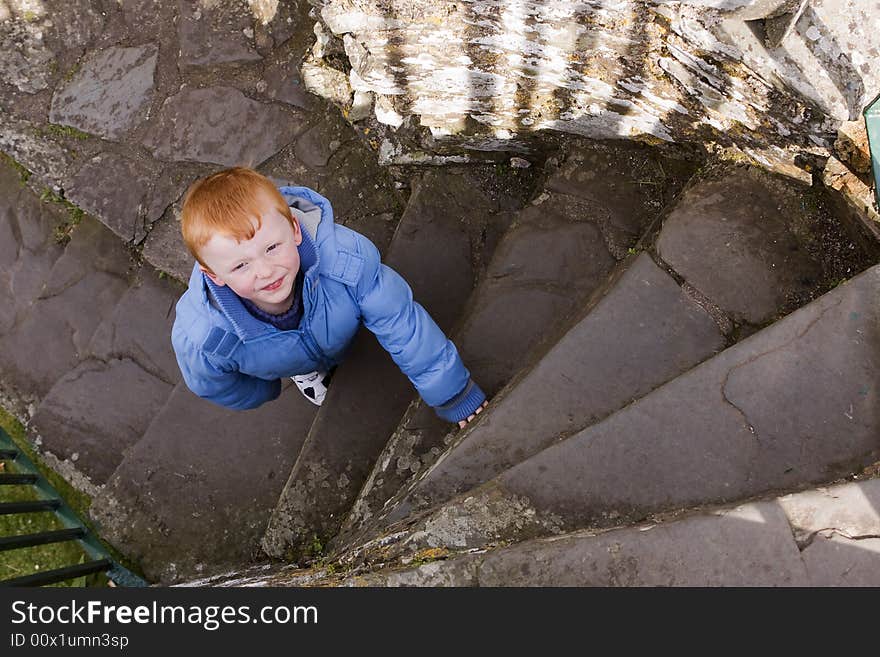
171 167 487 427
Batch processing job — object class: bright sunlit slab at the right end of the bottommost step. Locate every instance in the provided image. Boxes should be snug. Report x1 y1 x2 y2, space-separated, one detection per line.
779 479 880 544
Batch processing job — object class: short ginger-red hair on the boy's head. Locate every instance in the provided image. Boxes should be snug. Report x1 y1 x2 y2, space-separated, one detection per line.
180 167 295 271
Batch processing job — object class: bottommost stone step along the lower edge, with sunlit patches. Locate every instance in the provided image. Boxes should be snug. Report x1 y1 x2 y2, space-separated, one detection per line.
338 479 880 587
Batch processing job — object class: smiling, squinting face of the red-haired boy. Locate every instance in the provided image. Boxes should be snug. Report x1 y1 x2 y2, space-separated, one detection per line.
199 195 302 315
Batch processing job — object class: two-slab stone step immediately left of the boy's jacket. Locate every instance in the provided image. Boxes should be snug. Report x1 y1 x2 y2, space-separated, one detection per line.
31 266 181 485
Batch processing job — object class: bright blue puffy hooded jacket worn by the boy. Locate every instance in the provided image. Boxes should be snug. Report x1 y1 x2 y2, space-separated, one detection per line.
171 187 485 422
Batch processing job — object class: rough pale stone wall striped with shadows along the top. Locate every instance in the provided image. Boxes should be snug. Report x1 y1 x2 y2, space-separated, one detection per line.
303 0 880 172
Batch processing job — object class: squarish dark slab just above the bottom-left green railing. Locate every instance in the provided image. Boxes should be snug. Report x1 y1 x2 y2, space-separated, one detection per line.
30 359 174 485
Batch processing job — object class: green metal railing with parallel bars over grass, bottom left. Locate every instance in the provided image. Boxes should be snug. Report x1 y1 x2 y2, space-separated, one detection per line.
0 428 148 587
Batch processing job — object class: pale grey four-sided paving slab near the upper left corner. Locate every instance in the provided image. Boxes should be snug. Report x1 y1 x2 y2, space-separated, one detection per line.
49 45 159 139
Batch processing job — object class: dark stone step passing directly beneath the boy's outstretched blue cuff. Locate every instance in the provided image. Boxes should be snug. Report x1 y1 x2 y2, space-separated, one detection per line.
337 144 690 544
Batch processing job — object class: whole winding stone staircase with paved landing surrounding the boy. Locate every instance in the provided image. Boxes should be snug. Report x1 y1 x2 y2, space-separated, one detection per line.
0 2 880 586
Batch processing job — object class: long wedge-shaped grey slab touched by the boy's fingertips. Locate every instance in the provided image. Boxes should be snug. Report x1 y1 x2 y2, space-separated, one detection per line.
382 253 725 519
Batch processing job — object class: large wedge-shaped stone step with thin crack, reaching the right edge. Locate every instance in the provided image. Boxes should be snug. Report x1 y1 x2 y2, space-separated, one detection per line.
374 266 880 551
